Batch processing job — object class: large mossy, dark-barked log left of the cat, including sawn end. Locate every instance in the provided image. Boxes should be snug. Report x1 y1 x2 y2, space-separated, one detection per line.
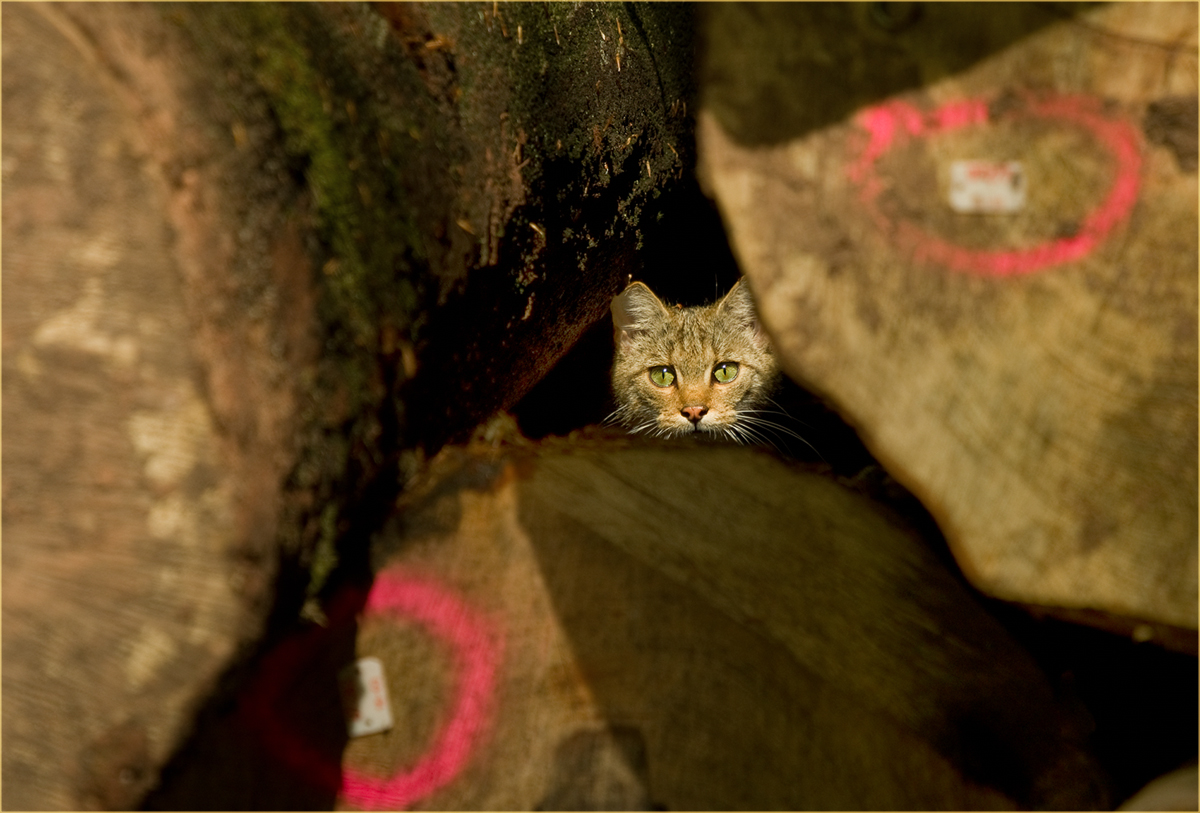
2 4 694 809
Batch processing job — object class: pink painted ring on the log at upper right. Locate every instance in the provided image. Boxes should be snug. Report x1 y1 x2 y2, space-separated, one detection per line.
847 96 1141 277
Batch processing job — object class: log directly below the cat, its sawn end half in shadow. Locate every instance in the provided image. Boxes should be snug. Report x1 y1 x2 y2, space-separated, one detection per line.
155 430 1108 809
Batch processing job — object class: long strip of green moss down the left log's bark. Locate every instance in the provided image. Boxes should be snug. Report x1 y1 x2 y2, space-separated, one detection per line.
167 4 440 595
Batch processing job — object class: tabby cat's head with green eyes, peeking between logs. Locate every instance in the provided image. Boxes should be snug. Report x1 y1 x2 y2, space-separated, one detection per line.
612 279 779 440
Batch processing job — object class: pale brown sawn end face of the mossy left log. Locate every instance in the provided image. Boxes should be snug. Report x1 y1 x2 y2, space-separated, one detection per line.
2 4 297 809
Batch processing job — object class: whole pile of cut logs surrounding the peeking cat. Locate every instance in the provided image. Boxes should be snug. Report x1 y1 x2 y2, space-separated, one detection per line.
2 4 1196 809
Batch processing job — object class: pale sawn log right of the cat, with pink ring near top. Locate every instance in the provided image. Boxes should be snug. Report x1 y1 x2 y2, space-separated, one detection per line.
698 4 1198 637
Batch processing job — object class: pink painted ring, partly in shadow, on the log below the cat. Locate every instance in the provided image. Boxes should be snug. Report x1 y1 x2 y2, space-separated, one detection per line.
244 571 503 809
